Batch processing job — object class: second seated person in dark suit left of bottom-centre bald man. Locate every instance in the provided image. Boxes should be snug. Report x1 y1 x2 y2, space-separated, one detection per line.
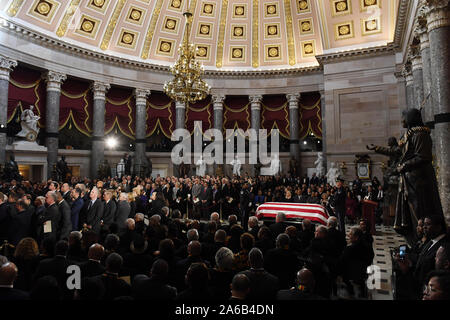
132 259 177 301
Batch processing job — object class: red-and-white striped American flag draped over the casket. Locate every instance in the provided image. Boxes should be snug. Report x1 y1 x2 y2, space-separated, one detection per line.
256 202 329 225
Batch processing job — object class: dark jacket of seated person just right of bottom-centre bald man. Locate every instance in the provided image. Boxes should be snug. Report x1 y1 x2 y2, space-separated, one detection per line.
241 269 280 301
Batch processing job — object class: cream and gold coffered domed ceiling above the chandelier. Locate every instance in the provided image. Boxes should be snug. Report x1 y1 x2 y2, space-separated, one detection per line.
0 0 398 71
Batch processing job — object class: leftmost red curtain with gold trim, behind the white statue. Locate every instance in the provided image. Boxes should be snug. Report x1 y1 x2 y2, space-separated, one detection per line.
7 66 47 128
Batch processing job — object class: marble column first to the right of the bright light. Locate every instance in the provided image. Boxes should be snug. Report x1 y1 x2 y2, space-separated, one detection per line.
134 89 150 175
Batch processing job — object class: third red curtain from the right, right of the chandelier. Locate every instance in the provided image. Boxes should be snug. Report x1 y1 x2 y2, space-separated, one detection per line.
223 96 251 138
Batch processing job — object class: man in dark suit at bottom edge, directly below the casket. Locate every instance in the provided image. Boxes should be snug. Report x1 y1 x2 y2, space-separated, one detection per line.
277 268 324 300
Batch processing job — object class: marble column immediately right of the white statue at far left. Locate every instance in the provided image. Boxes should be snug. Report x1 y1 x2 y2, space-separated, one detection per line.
44 71 67 178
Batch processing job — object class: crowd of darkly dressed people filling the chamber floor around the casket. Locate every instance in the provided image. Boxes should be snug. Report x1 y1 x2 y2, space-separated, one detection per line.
0 172 448 301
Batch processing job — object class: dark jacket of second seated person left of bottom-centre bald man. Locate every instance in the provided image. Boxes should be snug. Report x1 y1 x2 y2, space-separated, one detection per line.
132 275 177 301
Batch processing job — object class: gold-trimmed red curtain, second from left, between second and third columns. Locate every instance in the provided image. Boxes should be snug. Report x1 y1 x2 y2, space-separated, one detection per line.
59 78 93 136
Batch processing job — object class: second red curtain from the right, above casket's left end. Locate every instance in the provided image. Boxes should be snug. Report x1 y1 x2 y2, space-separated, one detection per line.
261 95 290 139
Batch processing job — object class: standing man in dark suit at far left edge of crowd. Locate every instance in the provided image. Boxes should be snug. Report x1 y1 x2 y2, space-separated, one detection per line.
8 199 31 246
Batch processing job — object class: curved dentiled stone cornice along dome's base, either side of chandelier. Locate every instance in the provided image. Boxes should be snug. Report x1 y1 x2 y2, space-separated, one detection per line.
0 18 322 78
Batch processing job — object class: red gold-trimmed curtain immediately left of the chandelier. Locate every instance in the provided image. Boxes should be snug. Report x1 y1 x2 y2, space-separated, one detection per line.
146 91 175 139
